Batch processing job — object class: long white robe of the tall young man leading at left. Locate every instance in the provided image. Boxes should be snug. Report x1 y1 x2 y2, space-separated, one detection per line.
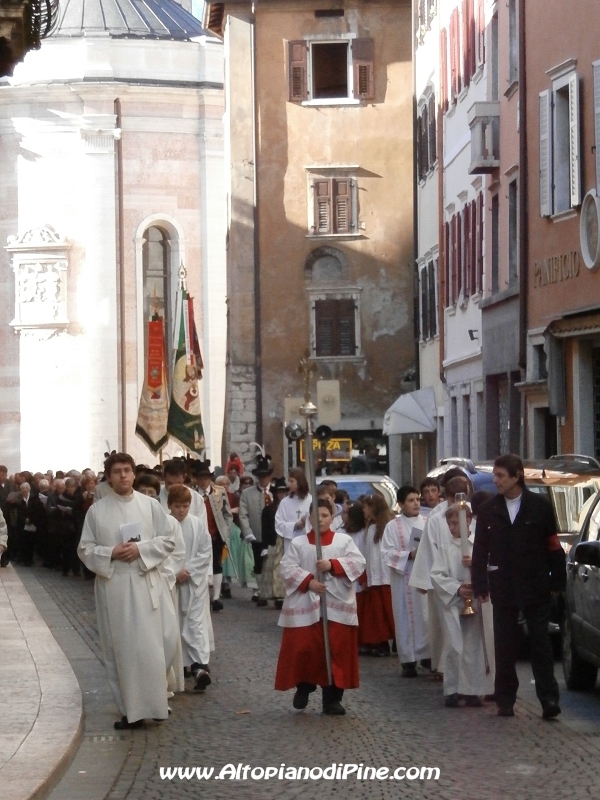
77 492 179 722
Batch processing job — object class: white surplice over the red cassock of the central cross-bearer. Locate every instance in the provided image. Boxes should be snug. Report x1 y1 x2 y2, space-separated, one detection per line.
278 533 365 628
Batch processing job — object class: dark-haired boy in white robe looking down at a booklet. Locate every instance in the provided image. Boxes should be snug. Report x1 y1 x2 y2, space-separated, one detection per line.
381 486 431 678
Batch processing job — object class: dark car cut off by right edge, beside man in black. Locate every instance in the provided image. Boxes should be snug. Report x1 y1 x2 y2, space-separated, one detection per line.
561 492 600 691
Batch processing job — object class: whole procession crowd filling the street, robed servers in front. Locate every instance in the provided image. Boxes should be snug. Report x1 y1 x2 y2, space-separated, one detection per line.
0 453 565 729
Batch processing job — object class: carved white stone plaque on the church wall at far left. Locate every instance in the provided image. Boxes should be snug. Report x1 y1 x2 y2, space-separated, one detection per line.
6 225 69 330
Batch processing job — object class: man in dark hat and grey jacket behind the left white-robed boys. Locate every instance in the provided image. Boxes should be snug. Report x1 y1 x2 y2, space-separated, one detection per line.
197 461 233 611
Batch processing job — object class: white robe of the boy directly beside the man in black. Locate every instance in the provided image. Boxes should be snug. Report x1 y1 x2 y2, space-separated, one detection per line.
431 536 494 696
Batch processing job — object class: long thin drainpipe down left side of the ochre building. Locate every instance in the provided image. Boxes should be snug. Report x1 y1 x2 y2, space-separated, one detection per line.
250 3 263 444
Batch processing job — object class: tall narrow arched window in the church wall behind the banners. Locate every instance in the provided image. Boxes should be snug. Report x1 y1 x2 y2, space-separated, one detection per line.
142 225 173 376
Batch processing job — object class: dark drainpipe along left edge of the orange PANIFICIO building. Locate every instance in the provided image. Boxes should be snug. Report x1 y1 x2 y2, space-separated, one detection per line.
518 0 529 456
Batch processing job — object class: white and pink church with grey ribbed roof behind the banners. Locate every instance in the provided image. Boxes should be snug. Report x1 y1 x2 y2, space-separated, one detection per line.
0 0 226 471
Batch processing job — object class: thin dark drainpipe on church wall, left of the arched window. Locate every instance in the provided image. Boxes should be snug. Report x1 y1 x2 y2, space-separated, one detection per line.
114 97 127 453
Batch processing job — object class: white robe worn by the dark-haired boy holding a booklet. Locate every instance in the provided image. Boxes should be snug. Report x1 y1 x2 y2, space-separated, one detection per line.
381 514 429 664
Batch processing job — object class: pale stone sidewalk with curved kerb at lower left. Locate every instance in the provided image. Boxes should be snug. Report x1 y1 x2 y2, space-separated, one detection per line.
0 566 83 800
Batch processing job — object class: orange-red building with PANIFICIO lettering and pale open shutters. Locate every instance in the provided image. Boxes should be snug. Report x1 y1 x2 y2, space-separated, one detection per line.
521 0 600 457
